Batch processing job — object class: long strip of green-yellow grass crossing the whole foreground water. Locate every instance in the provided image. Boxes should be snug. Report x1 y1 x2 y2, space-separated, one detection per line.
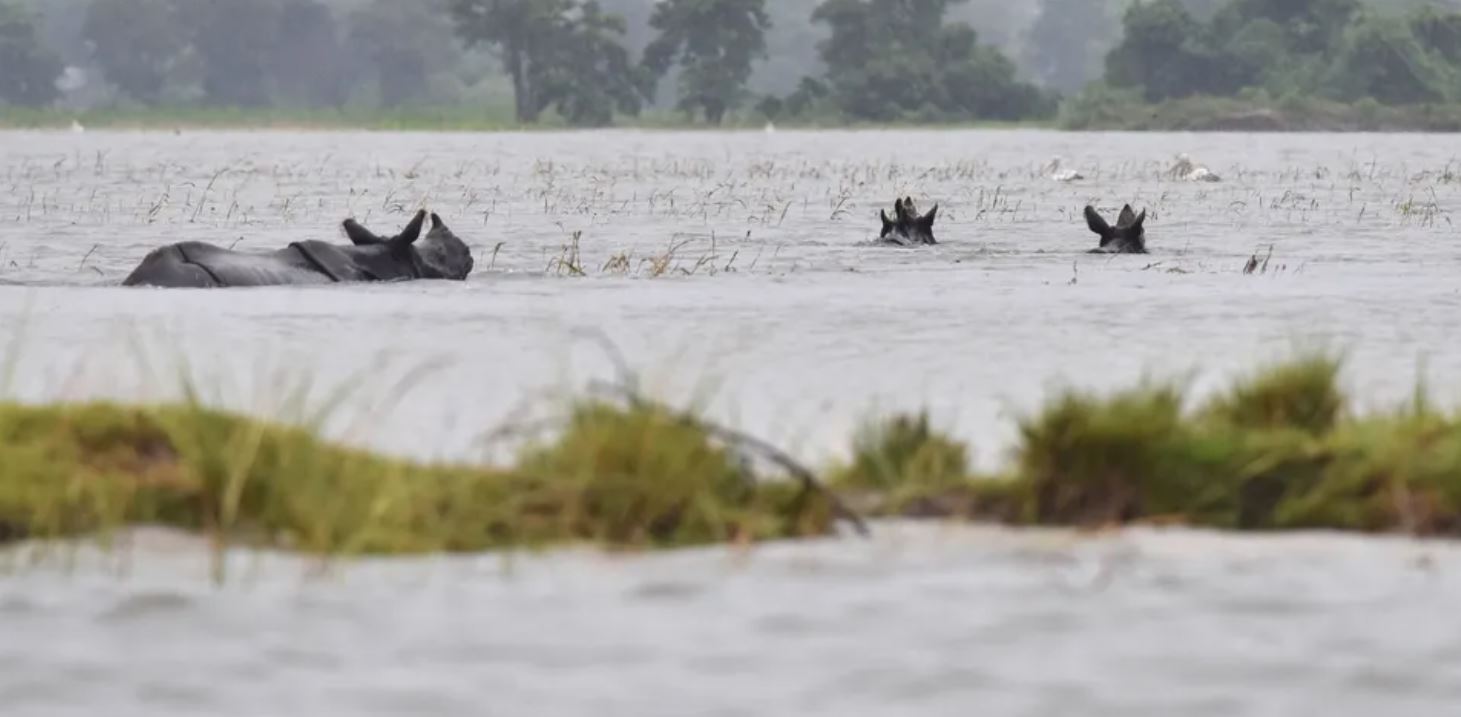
0 356 1461 555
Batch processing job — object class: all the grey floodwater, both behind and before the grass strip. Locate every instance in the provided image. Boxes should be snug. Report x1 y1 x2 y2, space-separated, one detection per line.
0 131 1461 716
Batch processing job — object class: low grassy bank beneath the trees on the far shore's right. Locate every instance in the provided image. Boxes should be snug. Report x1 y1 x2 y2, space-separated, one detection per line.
1059 88 1461 131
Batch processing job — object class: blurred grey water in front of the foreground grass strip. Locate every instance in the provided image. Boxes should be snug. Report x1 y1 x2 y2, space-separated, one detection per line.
0 524 1461 717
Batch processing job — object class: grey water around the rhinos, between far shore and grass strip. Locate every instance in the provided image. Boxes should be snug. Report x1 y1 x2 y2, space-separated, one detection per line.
0 131 1461 464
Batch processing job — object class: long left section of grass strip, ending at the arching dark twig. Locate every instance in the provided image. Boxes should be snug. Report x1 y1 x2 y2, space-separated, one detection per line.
0 403 830 553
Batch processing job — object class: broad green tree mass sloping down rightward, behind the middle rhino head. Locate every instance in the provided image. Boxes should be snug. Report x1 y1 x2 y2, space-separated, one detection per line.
812 0 1050 121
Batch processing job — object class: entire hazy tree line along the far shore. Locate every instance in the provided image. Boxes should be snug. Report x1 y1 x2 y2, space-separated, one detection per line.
0 0 1461 126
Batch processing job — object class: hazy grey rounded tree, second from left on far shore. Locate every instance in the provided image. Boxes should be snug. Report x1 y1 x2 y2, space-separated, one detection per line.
82 0 191 102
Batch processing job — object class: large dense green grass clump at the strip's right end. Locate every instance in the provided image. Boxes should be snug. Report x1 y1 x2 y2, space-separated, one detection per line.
1012 356 1461 534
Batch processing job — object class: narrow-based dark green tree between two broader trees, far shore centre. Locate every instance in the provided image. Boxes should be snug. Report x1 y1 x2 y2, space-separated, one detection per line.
644 0 771 124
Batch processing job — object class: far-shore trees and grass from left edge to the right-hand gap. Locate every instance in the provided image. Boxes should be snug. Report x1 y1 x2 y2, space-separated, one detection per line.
0 0 1053 126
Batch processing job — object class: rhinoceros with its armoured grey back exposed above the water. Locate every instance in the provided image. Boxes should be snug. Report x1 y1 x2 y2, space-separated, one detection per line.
123 210 472 288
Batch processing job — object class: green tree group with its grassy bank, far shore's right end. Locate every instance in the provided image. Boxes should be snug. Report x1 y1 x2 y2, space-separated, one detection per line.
1065 0 1461 130
